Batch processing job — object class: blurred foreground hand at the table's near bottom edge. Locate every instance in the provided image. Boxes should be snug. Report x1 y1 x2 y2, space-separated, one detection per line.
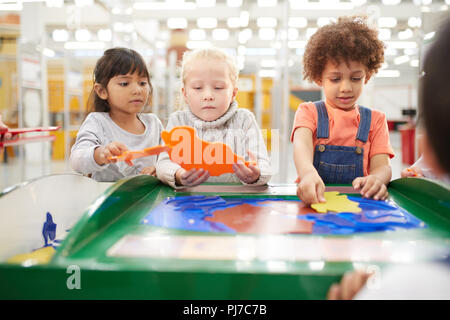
327 271 371 300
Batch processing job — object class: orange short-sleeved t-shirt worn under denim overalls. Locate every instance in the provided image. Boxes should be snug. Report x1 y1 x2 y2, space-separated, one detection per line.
291 102 394 176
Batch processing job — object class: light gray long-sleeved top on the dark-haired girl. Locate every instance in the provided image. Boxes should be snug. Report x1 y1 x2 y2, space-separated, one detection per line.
70 112 163 182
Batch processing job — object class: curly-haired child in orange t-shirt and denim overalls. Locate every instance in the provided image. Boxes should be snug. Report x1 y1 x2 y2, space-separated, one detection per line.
291 17 394 204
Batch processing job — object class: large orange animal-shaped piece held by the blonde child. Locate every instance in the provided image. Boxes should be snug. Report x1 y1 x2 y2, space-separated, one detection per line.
161 126 256 176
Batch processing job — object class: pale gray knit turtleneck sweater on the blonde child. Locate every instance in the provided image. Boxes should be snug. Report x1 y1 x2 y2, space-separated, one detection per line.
156 102 271 188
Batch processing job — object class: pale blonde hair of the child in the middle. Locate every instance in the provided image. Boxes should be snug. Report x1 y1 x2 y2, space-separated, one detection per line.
181 48 239 87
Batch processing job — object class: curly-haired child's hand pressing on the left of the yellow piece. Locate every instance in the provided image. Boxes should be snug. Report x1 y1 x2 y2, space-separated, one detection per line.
296 170 326 205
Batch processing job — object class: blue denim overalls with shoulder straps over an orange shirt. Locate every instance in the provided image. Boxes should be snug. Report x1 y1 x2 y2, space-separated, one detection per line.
313 101 372 184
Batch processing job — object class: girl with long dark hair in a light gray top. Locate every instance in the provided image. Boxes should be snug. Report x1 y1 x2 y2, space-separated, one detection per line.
70 48 163 182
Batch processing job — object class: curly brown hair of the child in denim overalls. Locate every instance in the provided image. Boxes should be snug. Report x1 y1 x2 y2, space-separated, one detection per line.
303 16 384 81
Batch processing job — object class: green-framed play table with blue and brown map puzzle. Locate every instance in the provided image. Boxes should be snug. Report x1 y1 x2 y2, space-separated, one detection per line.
0 174 450 299
